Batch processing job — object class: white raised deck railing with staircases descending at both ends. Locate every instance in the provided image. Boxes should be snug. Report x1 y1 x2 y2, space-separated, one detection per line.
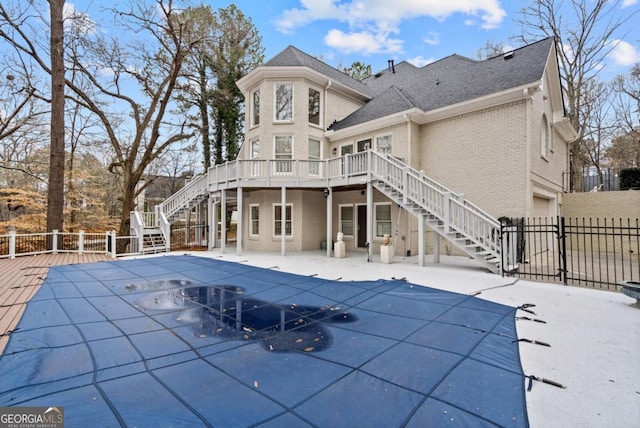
150 150 502 273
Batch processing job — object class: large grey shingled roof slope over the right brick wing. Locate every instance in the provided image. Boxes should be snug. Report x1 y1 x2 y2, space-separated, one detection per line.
327 37 554 130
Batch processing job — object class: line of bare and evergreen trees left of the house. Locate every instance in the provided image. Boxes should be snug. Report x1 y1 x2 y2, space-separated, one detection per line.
0 0 264 241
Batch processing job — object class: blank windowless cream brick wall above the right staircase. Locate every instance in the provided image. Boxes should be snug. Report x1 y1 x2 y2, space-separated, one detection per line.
419 101 528 217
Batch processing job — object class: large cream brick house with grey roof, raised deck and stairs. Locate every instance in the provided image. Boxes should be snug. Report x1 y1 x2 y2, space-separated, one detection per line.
148 38 576 271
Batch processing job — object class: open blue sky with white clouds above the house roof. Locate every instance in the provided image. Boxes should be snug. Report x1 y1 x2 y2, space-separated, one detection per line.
202 0 640 76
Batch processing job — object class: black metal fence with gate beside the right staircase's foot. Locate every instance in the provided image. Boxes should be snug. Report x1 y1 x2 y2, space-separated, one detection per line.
501 217 640 290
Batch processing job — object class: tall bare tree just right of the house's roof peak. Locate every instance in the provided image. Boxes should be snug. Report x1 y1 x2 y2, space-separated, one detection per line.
518 0 635 188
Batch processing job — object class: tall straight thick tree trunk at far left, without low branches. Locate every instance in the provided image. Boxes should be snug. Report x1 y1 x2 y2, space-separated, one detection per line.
47 0 64 244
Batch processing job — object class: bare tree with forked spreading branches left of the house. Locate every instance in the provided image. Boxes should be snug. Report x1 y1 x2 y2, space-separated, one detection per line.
61 0 200 242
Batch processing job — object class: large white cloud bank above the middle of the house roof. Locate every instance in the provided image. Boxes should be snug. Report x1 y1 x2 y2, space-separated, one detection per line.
275 0 506 53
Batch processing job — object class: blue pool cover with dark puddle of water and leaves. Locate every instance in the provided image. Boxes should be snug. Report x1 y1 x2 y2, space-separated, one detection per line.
0 256 528 428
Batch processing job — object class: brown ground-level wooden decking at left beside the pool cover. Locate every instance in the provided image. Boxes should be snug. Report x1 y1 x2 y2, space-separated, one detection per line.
0 253 112 355
